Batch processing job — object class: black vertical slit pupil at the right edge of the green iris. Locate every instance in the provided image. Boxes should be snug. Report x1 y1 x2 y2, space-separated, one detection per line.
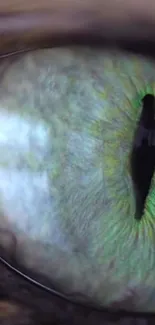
131 94 155 220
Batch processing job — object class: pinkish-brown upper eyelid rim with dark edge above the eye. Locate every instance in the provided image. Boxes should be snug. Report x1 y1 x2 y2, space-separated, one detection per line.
0 11 155 59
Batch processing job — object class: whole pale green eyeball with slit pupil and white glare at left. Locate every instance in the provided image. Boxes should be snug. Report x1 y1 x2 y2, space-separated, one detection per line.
0 48 155 311
